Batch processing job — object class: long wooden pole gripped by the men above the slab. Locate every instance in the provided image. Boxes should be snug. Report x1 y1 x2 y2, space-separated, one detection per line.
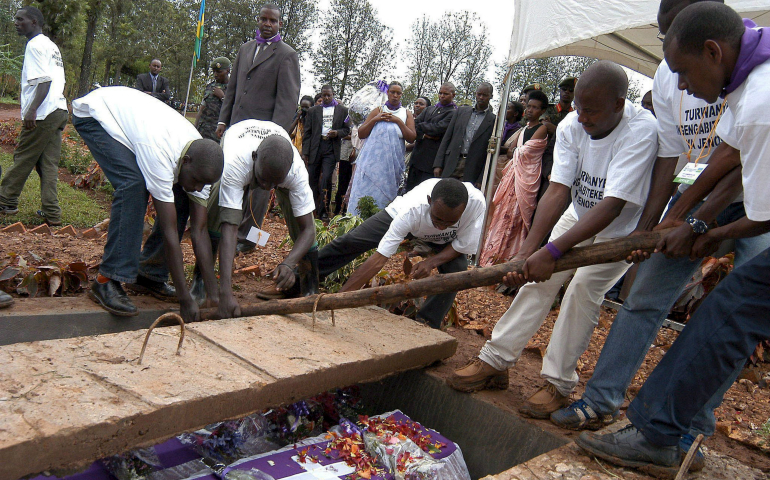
201 230 669 320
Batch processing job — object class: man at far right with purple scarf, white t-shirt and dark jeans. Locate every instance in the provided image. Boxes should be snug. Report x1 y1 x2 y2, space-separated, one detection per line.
576 2 770 476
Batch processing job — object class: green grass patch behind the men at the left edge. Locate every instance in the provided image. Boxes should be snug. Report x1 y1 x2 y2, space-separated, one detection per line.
0 153 109 228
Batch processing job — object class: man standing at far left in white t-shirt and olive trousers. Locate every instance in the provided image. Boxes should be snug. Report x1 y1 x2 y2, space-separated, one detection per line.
0 7 67 225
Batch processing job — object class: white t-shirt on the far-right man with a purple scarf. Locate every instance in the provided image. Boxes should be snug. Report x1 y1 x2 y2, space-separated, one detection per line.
717 61 770 222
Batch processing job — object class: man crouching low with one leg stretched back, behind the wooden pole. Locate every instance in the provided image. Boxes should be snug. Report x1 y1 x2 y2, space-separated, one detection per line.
318 178 485 328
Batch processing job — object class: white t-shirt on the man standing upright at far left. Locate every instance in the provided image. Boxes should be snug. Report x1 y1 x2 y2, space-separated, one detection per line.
19 33 67 120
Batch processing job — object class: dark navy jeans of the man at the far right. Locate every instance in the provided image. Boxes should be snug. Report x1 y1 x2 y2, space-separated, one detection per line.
628 249 770 445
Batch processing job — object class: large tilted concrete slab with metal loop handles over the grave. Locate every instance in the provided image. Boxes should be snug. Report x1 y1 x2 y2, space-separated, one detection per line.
0 307 457 479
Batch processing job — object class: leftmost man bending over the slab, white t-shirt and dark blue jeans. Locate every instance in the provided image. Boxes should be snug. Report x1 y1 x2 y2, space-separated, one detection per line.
72 87 223 322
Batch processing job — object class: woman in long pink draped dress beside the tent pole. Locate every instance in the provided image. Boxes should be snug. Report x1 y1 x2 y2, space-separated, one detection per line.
479 91 548 267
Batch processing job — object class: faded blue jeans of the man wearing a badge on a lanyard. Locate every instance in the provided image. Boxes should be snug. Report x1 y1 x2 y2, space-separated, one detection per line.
583 193 770 436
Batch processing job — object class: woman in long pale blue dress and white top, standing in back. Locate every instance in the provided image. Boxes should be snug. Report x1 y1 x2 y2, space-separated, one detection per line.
348 82 417 215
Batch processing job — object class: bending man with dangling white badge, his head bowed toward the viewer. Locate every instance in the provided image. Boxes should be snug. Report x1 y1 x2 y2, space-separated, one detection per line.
200 120 318 318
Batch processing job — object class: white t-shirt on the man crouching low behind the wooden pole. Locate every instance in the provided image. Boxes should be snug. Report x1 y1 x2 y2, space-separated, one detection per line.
377 178 486 257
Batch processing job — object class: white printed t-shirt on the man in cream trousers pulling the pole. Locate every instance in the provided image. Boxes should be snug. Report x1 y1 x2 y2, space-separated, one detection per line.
551 100 658 238
